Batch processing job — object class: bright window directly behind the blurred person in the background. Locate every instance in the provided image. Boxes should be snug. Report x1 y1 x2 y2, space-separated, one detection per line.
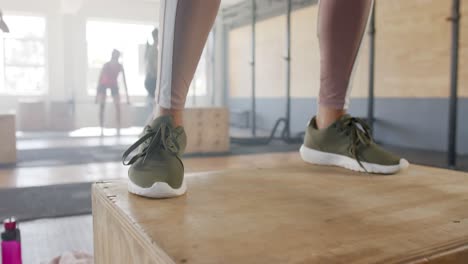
86 20 154 96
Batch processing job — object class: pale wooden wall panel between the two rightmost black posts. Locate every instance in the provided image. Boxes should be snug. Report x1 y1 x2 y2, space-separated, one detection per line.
375 0 451 98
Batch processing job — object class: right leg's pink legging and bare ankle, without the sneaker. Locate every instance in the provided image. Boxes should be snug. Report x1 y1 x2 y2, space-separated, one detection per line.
317 0 373 128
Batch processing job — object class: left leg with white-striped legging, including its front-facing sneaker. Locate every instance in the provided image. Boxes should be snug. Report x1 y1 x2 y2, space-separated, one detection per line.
123 0 220 198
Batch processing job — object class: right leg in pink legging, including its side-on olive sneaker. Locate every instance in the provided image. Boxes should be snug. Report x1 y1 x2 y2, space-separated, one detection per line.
300 0 408 174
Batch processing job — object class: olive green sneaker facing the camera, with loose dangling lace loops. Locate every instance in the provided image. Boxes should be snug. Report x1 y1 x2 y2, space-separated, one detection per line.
122 116 187 198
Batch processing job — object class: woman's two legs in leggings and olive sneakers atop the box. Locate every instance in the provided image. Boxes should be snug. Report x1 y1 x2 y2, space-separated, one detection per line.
123 0 408 198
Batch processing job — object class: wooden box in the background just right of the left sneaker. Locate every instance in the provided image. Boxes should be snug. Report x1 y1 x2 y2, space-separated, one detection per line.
184 107 230 153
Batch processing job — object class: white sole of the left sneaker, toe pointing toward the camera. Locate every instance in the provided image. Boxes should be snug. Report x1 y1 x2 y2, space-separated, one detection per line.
128 179 187 199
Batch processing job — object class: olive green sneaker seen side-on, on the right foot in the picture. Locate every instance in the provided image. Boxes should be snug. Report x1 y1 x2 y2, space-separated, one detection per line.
300 115 409 174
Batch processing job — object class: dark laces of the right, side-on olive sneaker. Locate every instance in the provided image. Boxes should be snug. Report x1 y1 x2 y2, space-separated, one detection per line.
339 117 373 172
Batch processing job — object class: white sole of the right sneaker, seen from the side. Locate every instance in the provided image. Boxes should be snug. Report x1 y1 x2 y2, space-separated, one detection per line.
299 145 409 174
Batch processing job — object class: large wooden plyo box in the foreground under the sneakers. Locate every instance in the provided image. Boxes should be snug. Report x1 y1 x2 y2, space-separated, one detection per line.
93 164 468 264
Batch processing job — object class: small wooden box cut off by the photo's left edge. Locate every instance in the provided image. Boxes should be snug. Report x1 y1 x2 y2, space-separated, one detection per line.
0 114 16 164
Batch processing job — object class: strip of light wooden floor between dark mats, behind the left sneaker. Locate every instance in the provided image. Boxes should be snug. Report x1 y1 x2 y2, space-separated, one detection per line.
0 152 297 188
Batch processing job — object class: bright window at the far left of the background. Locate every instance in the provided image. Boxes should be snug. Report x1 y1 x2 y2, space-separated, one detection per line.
0 16 46 95
